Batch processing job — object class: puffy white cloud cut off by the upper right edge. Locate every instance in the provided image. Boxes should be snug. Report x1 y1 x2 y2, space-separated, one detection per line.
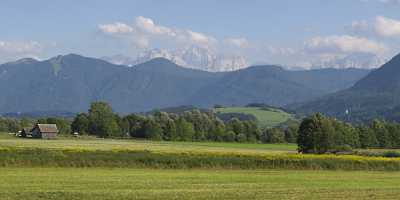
374 16 400 37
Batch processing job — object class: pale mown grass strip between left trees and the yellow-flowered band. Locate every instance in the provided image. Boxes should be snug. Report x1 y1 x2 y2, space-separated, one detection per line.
0 134 297 154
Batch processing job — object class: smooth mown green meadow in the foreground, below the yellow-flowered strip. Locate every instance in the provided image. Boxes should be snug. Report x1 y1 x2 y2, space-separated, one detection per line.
0 168 400 200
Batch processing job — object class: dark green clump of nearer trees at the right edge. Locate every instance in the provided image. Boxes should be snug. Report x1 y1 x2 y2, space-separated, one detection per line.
297 113 400 153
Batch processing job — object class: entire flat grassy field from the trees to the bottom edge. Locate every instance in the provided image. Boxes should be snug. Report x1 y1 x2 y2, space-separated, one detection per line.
0 135 400 200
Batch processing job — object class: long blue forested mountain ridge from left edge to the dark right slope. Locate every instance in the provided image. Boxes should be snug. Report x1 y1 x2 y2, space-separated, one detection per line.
0 54 369 113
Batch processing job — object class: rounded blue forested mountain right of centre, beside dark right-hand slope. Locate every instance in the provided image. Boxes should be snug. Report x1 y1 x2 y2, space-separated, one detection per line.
189 66 367 106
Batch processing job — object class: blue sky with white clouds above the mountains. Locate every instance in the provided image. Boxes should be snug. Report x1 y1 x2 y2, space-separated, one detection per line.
0 0 400 68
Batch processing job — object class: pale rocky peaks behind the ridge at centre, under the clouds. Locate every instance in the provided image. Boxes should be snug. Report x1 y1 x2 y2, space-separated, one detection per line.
100 46 249 72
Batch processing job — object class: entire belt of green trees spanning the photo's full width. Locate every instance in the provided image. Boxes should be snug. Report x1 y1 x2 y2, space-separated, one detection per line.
0 102 400 153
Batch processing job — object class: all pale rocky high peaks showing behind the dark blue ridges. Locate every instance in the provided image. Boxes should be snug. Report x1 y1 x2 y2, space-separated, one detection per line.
100 46 387 72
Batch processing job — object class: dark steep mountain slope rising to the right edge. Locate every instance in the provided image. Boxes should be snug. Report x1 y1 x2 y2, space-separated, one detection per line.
289 55 400 121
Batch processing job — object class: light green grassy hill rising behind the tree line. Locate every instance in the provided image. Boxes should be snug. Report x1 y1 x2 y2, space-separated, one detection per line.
216 107 293 128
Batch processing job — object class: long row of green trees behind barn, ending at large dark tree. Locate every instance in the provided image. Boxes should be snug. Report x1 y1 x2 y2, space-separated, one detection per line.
0 102 298 143
